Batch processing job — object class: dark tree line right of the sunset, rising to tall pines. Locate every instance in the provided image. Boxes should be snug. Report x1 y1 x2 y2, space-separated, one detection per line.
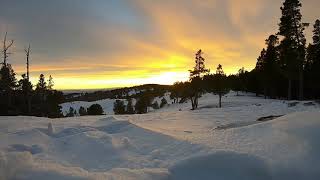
171 0 320 110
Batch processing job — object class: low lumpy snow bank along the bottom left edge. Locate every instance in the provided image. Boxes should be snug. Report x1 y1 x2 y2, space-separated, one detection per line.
0 152 168 180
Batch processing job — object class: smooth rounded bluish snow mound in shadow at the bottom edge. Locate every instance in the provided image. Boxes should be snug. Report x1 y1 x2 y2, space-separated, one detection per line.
169 151 272 180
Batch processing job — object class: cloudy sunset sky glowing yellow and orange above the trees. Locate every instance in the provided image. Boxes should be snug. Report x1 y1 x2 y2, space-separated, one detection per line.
0 0 320 89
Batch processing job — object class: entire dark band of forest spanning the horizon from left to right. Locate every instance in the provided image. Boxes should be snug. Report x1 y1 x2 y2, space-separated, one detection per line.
0 0 320 118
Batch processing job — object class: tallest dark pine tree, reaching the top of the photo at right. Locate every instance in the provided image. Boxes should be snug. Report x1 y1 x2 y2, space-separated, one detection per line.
278 0 306 100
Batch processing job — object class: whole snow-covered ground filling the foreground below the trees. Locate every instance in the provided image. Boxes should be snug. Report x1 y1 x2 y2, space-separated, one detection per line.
0 93 320 180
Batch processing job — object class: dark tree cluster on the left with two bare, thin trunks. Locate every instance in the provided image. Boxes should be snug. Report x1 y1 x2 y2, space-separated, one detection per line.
0 33 64 118
